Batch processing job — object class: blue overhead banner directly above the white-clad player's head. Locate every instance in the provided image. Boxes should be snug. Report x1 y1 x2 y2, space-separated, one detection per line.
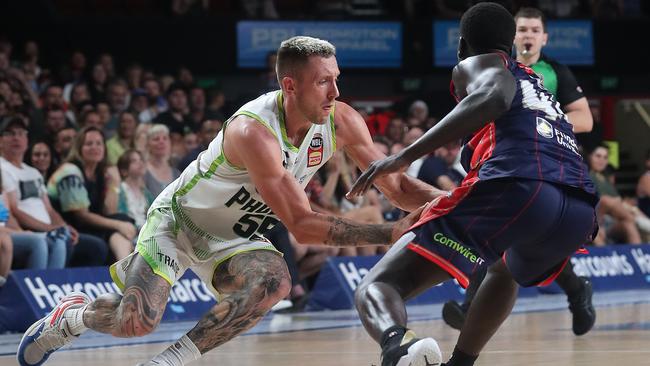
237 21 402 68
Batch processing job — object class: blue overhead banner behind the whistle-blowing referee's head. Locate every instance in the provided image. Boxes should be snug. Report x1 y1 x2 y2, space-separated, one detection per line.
433 20 594 67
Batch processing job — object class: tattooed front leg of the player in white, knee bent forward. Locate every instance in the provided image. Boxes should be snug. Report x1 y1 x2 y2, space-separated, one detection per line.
187 250 291 354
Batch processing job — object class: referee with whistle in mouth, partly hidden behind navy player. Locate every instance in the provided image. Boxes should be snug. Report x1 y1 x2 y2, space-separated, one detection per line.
442 8 596 335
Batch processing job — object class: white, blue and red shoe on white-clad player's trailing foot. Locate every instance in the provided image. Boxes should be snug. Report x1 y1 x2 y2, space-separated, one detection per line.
16 292 90 366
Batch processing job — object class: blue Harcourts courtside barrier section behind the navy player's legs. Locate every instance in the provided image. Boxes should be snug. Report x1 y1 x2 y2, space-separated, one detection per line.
309 245 650 310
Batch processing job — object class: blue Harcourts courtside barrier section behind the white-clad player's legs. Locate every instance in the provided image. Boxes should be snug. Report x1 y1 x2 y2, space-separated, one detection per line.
0 267 216 332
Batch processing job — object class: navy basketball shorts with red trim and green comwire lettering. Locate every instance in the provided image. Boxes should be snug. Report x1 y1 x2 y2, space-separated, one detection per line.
405 178 598 287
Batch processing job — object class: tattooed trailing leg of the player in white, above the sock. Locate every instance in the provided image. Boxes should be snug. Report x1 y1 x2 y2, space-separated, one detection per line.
83 255 171 337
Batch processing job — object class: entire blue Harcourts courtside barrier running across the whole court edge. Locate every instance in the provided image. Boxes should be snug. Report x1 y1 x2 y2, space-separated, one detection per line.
0 245 650 332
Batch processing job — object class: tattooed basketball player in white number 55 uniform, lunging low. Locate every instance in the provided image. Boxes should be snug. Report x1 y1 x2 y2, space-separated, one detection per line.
17 37 441 366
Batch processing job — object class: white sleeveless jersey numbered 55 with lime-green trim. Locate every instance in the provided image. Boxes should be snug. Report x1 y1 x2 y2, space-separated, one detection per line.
151 91 336 260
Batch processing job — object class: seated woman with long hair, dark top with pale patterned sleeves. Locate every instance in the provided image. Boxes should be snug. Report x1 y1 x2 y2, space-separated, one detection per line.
47 127 136 260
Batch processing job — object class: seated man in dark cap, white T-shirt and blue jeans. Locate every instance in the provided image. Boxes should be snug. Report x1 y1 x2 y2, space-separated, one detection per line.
0 118 71 269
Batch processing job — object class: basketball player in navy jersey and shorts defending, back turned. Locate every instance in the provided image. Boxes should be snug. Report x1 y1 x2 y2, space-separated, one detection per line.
349 3 598 366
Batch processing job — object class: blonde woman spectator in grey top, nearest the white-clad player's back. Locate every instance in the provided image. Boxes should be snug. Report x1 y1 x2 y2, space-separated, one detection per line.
144 124 180 196
